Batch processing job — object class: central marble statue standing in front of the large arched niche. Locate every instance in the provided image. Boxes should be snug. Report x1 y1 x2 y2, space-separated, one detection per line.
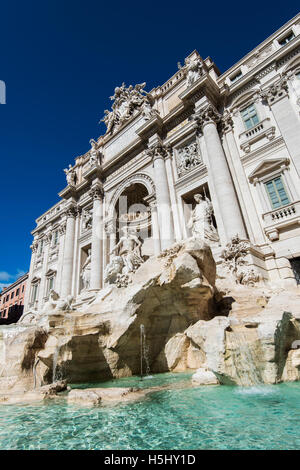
110 226 144 274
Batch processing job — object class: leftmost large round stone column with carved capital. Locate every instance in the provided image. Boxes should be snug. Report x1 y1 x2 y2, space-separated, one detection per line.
61 205 77 298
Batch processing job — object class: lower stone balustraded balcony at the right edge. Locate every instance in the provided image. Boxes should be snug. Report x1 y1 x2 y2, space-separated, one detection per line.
262 201 300 241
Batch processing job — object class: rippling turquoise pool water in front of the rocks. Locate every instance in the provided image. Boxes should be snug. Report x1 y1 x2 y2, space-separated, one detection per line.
0 374 300 450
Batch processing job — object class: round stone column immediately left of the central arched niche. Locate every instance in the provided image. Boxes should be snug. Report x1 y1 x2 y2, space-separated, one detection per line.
90 183 103 290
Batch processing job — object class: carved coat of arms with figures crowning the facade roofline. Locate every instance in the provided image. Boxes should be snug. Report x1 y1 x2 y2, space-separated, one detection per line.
101 83 156 134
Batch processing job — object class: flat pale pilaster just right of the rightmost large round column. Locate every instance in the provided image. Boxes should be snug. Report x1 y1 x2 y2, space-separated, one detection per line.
222 115 265 244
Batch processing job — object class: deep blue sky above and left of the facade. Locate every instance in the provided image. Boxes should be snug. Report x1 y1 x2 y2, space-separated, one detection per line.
0 0 299 287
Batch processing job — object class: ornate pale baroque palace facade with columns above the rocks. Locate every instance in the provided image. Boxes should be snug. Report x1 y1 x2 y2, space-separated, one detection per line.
25 15 300 311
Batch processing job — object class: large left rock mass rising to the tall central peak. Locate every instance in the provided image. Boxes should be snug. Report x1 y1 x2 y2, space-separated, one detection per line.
0 239 219 391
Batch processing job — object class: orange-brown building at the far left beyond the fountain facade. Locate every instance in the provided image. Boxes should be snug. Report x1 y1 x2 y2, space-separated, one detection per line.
0 273 29 323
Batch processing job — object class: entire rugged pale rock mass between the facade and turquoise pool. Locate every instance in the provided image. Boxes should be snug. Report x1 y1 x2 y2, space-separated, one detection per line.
0 239 300 392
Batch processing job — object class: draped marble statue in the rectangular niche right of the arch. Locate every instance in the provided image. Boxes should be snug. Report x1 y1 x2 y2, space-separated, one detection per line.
188 194 219 244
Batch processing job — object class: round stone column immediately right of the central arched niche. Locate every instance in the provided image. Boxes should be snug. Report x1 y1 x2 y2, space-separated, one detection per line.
150 144 174 250
